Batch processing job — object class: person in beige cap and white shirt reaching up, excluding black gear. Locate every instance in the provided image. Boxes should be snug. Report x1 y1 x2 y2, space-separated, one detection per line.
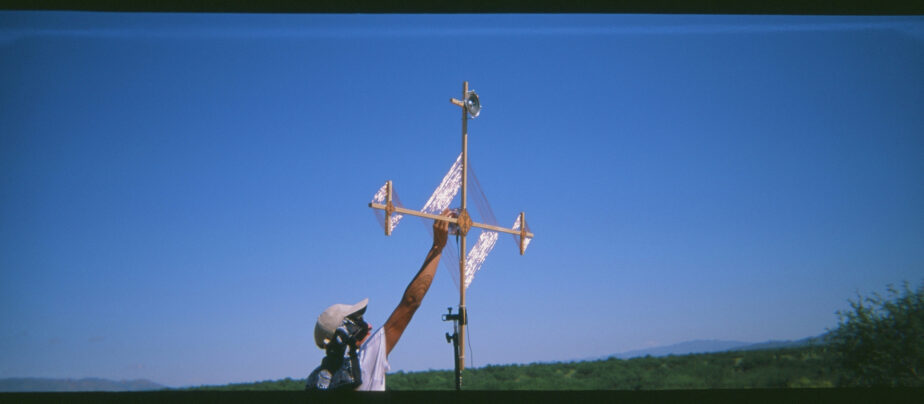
306 210 451 391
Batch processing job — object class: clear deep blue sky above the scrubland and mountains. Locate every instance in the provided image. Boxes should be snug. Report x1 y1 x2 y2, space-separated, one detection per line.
0 12 924 386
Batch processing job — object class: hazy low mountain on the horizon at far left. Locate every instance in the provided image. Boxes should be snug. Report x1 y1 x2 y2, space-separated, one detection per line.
0 377 167 392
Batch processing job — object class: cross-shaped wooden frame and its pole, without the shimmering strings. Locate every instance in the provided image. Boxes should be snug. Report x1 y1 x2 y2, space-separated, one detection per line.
369 81 534 390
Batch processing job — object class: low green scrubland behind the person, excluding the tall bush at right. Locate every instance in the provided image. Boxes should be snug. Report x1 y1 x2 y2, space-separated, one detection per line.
188 346 837 391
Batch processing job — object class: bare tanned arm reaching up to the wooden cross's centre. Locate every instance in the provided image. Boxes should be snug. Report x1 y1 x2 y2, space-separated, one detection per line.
384 210 449 355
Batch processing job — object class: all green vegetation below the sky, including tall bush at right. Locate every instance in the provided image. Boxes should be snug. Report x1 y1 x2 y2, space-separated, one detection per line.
184 283 924 390
